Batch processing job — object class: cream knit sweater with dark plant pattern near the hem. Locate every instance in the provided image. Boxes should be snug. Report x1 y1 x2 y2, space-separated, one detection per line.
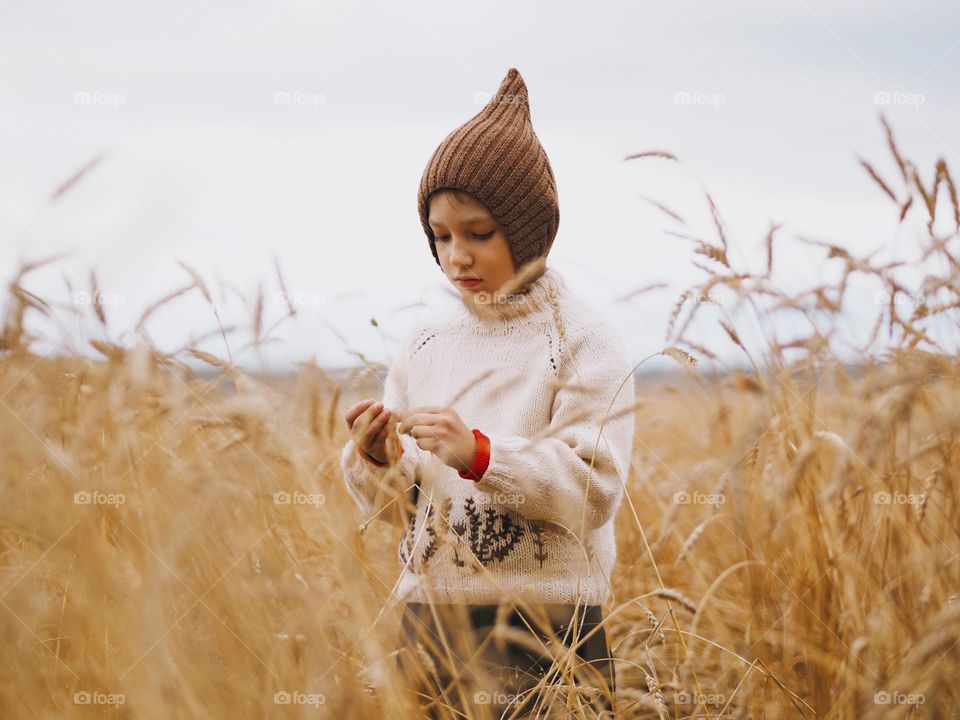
340 268 635 604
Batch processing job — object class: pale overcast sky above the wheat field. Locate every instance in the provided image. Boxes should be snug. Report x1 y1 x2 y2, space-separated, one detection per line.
0 0 960 370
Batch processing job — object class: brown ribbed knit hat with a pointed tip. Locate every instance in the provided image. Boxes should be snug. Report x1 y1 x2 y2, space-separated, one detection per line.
417 68 560 271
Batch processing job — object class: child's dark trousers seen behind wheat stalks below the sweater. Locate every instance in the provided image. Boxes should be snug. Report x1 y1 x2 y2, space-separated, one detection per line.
397 603 616 718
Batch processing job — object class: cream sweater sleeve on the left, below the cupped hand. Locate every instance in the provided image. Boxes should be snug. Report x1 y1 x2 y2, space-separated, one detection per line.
340 331 423 527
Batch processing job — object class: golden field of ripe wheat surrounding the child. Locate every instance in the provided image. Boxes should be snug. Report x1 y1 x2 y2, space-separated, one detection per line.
0 115 960 720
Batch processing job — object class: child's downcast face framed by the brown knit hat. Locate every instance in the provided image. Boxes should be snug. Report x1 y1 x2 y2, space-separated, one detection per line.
428 191 515 300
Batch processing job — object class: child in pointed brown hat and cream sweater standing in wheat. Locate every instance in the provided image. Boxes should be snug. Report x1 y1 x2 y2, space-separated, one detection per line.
341 68 635 716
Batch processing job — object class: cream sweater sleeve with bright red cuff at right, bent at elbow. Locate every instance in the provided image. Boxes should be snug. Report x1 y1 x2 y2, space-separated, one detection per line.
476 322 636 534
